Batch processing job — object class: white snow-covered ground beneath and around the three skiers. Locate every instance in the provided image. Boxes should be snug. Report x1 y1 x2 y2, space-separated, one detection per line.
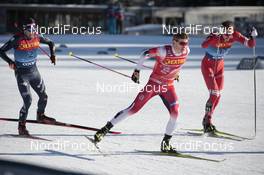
0 36 264 174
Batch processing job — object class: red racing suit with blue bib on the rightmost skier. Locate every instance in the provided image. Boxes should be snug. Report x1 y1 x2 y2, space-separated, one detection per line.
201 31 256 123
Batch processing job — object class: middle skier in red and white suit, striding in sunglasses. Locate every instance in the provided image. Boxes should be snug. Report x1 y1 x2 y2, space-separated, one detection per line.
94 33 190 152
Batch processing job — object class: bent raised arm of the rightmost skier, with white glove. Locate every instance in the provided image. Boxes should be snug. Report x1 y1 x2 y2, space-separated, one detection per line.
234 27 258 48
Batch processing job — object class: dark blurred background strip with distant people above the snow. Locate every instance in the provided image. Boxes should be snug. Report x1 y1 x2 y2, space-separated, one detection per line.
0 0 264 36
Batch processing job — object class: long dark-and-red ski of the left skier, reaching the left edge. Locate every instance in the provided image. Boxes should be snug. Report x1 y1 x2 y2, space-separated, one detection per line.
0 118 121 134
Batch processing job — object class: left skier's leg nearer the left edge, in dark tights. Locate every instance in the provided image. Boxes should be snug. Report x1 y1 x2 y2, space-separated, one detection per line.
15 72 32 135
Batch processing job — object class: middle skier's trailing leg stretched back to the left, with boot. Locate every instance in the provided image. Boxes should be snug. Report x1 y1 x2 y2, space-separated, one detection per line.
94 82 157 143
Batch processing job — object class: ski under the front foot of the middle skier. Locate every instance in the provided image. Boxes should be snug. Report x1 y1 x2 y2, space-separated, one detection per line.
136 150 226 162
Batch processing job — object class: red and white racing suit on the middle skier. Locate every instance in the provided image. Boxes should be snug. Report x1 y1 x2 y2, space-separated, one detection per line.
110 45 190 135
